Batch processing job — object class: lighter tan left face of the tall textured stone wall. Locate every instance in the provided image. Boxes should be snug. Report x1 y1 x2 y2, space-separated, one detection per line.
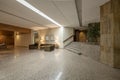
100 2 114 66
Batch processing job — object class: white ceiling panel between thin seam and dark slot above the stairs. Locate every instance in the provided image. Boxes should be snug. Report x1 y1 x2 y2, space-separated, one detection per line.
54 0 79 27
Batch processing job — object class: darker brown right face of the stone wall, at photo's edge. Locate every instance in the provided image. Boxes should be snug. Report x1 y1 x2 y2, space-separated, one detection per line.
112 0 120 68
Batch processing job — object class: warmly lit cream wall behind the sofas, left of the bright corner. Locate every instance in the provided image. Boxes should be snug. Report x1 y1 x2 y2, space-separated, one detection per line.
38 27 63 48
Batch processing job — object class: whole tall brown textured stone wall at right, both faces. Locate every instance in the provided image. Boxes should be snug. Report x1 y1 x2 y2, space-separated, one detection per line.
100 0 120 68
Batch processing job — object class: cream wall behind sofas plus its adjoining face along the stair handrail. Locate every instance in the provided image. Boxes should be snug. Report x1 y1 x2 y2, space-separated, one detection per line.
38 27 74 48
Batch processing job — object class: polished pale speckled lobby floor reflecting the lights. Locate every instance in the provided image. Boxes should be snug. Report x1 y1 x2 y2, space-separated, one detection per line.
0 49 120 80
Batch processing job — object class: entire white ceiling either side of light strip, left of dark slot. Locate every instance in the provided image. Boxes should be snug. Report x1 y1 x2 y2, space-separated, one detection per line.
0 0 79 29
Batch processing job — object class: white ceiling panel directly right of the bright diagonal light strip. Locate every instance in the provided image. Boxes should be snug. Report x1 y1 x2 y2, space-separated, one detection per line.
27 0 68 26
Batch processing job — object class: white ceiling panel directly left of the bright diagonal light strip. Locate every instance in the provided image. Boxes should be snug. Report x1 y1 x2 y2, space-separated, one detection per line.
0 0 56 25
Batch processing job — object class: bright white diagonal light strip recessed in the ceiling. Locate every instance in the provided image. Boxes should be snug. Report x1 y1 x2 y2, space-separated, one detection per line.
16 0 63 27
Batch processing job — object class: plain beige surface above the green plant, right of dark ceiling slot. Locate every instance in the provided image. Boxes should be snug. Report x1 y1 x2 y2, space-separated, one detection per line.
82 0 109 26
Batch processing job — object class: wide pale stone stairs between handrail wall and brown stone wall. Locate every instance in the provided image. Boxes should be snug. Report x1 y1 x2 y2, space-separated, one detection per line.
65 42 100 61
